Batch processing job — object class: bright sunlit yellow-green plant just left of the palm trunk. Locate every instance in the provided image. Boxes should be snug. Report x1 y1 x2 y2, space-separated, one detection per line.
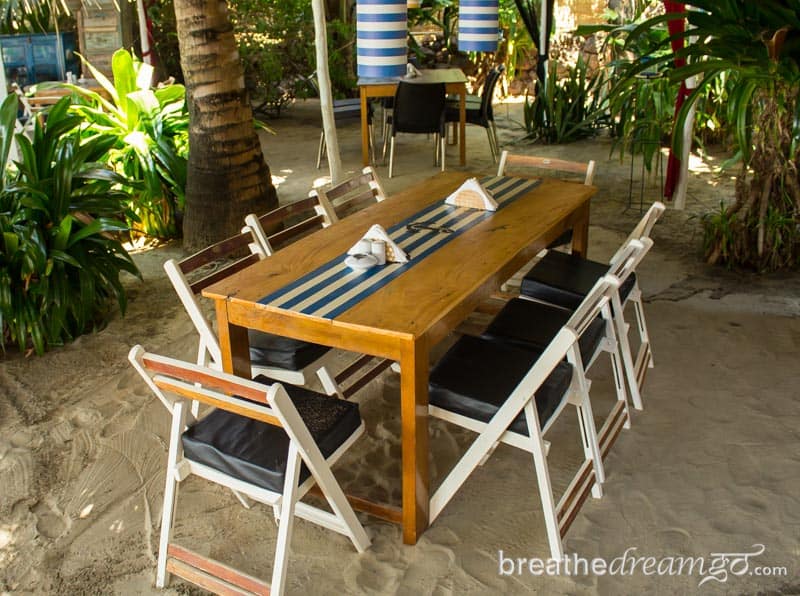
67 49 189 238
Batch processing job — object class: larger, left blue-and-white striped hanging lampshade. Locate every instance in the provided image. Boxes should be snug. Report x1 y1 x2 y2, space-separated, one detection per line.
356 0 408 78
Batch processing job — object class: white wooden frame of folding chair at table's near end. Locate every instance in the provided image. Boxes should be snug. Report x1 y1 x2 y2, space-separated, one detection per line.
128 346 370 594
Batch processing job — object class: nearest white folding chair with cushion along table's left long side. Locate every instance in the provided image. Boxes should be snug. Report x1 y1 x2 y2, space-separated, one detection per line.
164 230 344 397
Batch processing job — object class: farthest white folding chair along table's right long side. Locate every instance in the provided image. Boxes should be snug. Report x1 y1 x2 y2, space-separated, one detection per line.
520 201 665 409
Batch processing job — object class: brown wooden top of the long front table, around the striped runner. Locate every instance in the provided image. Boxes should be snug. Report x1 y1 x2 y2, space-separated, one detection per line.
203 172 596 347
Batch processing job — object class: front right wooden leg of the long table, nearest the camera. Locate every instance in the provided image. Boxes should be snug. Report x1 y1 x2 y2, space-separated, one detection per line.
400 341 430 544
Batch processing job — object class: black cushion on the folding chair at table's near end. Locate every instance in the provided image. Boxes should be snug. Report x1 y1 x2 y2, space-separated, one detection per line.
182 376 361 493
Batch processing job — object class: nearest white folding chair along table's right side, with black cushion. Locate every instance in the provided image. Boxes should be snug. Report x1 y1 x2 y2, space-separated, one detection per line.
428 276 619 559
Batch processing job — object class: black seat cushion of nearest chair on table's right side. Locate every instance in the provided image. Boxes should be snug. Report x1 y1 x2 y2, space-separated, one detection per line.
429 335 572 435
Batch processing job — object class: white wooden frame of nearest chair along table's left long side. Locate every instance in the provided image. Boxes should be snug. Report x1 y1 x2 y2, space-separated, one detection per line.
164 229 344 398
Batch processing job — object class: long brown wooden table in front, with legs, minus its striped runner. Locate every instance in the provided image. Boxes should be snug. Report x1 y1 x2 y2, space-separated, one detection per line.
203 172 596 544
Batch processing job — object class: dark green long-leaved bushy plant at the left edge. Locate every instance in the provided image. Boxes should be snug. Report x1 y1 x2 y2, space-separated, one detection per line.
0 95 139 354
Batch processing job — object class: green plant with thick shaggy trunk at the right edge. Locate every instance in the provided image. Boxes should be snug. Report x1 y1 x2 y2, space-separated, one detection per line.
612 0 800 270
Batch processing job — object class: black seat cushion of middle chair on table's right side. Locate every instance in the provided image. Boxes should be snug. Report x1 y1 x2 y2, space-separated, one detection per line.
483 298 606 363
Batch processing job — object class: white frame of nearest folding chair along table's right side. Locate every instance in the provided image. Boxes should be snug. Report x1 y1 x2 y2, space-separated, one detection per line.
428 275 619 559
